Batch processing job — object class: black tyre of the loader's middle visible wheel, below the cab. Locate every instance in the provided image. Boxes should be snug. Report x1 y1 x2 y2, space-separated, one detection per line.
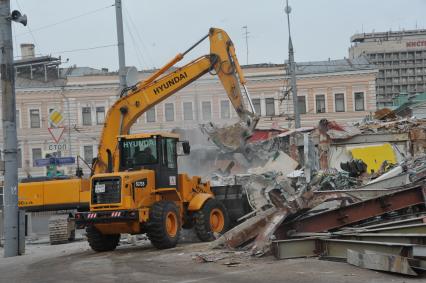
147 201 181 249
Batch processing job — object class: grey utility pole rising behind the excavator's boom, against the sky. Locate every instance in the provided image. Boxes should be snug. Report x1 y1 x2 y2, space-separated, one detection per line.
115 0 127 93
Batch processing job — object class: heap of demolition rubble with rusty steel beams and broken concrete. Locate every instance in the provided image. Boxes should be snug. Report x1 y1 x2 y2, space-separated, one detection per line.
211 119 426 275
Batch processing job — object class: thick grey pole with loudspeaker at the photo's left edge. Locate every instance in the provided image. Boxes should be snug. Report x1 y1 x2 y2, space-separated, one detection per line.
0 0 27 257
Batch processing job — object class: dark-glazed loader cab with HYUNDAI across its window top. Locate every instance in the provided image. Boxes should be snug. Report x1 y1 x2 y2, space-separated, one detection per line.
118 133 189 188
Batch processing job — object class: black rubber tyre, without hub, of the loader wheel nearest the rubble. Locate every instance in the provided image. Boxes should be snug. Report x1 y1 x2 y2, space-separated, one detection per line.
194 199 230 242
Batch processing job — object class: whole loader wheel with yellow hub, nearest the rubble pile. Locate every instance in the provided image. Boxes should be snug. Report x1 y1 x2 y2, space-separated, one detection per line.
195 199 229 242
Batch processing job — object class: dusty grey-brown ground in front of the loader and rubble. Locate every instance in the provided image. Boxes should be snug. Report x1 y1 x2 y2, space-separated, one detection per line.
0 241 426 283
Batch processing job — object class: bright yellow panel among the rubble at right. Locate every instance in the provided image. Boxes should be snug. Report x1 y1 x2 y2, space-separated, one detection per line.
347 143 397 173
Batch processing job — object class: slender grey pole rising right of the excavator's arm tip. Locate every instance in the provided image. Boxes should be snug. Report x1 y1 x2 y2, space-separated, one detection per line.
285 0 300 129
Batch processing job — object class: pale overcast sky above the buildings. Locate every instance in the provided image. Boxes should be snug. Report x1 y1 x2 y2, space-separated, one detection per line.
11 0 426 70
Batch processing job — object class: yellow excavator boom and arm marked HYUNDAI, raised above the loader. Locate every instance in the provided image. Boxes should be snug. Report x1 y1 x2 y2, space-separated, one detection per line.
93 28 253 174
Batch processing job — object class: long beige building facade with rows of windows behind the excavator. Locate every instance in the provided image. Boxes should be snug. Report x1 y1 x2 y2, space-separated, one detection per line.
0 61 377 178
